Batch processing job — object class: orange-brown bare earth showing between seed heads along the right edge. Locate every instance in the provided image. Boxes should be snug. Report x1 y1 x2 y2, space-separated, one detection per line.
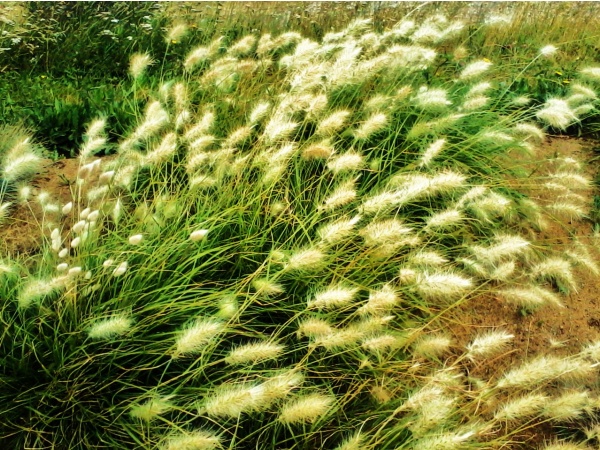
449 137 600 449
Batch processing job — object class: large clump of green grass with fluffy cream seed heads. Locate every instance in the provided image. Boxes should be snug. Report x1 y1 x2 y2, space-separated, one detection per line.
0 10 598 450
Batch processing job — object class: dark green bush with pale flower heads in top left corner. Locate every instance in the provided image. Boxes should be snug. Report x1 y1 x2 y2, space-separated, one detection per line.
0 1 165 77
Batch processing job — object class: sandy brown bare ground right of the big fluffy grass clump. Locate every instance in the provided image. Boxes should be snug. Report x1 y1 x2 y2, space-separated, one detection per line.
454 138 600 358
